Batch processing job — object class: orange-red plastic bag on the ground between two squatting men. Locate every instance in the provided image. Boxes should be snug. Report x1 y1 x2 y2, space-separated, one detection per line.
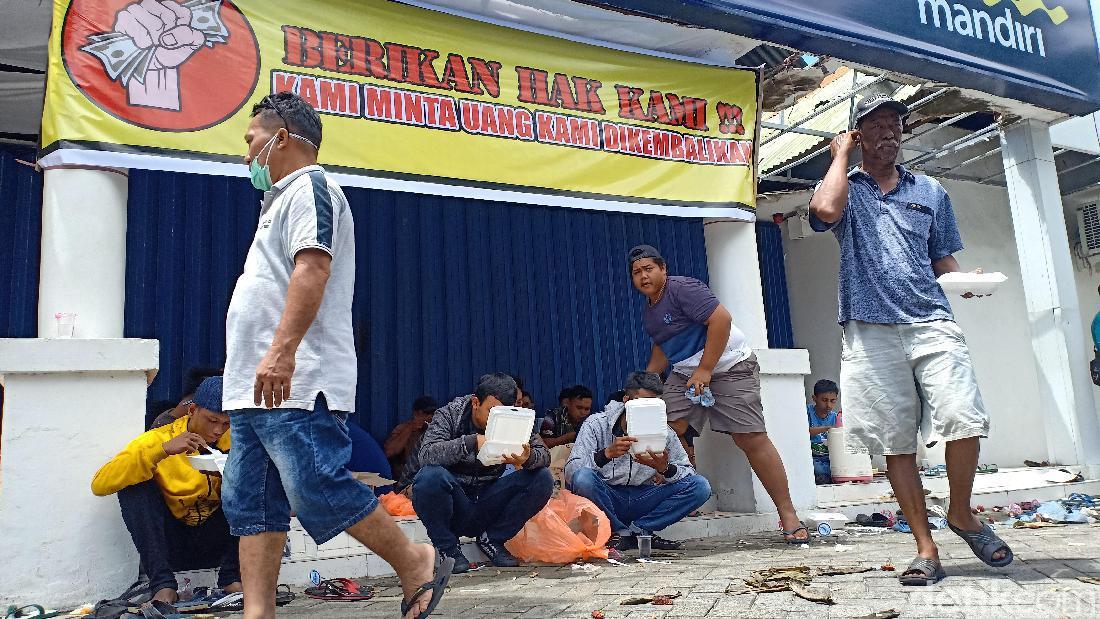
504 490 612 564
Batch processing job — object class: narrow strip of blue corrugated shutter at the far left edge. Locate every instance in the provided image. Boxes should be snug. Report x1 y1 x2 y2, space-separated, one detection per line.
0 151 42 419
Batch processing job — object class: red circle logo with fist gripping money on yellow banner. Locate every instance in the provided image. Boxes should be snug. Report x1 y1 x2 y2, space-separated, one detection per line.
62 0 260 131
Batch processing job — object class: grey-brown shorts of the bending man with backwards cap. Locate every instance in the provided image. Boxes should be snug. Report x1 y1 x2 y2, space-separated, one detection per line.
661 355 766 434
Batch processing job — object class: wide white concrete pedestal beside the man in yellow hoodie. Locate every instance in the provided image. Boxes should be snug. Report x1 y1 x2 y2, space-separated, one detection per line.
0 339 158 607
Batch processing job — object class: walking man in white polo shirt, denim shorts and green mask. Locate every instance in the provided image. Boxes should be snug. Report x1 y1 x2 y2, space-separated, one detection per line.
222 92 453 619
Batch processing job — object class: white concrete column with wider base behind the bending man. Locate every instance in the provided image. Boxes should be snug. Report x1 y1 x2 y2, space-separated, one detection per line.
695 220 816 512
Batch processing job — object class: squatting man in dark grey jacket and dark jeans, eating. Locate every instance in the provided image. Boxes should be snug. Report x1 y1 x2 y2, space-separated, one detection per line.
413 373 553 574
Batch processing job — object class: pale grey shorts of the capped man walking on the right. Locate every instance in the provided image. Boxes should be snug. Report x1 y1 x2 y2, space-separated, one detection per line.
840 320 989 455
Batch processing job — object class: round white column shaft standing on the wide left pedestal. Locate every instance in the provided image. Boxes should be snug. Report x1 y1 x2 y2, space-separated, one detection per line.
39 168 128 339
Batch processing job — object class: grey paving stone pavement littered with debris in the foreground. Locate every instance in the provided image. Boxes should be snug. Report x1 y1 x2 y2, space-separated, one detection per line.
229 524 1100 619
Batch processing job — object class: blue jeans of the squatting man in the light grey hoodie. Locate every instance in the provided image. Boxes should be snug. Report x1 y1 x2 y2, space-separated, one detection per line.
569 468 711 532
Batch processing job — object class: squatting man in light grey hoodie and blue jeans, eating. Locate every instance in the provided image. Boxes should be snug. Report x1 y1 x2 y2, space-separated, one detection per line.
565 372 711 550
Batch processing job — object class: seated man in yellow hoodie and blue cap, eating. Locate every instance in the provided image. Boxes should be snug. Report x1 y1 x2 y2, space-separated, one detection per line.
91 376 241 604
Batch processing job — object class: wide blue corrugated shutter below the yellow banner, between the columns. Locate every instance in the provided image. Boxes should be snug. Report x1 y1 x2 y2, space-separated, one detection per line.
125 170 707 440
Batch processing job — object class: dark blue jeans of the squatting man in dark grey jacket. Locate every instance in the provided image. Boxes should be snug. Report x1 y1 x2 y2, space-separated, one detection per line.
413 466 553 549
